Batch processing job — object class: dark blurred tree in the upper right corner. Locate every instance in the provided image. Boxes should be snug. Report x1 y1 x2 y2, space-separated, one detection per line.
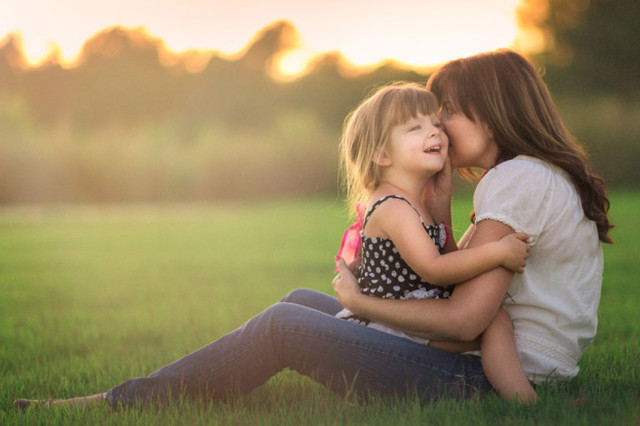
519 0 640 99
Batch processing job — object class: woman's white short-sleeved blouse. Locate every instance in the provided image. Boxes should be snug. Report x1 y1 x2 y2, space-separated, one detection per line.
473 156 603 383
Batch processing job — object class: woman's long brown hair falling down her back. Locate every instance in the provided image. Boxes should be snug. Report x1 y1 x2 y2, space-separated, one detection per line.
427 49 613 243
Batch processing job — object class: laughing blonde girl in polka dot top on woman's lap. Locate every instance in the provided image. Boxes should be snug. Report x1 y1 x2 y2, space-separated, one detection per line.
337 83 536 401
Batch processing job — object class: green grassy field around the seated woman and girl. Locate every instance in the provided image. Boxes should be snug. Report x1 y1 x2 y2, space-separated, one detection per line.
0 192 640 425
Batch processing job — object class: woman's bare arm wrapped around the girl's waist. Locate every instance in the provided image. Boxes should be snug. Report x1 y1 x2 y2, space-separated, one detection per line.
334 220 514 341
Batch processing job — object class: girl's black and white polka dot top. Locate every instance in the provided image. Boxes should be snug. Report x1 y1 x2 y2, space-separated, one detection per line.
357 195 453 299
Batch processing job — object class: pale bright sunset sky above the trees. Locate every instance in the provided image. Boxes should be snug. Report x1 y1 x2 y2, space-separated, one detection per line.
0 0 519 74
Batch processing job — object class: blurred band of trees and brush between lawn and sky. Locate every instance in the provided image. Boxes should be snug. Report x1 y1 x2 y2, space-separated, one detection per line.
0 5 640 203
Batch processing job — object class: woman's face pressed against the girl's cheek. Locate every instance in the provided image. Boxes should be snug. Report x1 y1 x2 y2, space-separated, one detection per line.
440 102 499 170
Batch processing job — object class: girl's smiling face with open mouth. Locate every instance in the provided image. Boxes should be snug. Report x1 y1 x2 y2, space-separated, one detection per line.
381 113 449 176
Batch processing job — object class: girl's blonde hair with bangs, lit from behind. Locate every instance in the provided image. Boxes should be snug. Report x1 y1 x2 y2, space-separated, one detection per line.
340 82 439 215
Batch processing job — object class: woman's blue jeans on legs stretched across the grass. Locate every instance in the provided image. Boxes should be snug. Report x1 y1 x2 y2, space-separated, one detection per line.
105 289 492 405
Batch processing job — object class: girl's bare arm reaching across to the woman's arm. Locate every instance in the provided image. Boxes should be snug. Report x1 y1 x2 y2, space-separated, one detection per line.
368 200 529 286
